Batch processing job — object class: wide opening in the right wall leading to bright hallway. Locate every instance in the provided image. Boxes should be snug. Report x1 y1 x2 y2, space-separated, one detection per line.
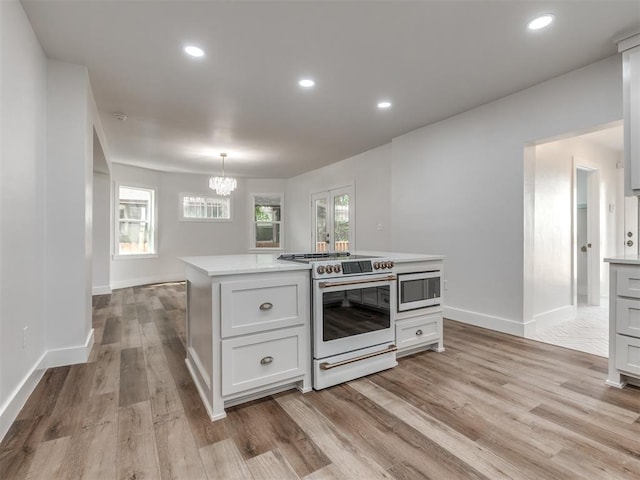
524 122 624 357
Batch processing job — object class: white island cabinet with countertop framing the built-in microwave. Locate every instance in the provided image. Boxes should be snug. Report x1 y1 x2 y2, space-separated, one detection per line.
394 260 444 357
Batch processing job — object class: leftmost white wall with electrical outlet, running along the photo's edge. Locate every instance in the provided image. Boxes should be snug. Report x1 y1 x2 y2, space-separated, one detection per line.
0 1 47 438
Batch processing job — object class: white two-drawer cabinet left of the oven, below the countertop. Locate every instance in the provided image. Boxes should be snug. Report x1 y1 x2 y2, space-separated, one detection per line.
186 267 311 420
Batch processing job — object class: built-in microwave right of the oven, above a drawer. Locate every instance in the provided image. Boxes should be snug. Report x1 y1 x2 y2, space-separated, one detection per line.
397 270 442 312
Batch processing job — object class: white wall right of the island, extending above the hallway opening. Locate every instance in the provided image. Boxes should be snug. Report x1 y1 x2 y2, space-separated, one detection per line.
391 55 622 335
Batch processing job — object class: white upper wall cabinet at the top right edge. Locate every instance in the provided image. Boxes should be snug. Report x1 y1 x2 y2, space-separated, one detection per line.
618 33 640 196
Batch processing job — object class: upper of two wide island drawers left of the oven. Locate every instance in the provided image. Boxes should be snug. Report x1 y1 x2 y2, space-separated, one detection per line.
220 277 309 338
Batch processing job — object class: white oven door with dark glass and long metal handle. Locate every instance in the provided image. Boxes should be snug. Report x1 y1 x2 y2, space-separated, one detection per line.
313 275 396 359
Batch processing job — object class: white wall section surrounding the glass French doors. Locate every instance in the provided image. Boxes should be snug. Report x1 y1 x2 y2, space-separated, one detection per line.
285 145 391 252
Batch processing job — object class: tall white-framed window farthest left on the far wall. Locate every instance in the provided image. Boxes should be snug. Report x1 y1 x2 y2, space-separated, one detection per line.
117 186 156 255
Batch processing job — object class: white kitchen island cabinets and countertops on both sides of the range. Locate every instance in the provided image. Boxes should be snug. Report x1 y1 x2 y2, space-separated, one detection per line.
181 252 443 420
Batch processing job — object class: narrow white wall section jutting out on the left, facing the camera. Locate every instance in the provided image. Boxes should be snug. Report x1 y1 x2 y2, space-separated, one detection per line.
45 59 93 360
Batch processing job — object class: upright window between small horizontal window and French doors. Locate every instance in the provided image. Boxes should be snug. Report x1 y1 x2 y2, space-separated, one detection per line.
251 193 282 249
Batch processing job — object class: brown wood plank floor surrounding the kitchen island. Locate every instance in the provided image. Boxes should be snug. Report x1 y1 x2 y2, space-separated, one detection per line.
0 283 640 480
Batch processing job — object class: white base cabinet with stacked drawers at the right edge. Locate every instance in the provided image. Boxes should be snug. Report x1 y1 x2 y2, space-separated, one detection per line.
607 259 640 388
